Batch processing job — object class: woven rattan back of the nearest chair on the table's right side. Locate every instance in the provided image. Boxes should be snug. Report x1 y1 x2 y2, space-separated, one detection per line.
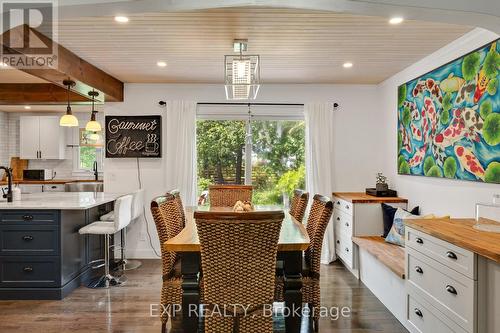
305 194 333 276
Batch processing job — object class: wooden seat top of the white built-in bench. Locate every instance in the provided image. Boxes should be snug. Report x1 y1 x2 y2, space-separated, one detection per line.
352 236 405 279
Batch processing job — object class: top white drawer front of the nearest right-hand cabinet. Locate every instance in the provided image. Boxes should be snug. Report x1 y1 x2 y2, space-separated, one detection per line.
406 227 476 279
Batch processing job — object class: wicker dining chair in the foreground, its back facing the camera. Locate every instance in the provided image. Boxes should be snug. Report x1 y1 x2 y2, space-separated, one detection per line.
194 211 284 333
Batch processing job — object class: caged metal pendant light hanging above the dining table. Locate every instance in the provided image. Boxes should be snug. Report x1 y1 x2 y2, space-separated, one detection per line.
224 39 260 100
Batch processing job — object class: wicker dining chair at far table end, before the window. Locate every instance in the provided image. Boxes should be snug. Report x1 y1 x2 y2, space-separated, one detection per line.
208 185 253 207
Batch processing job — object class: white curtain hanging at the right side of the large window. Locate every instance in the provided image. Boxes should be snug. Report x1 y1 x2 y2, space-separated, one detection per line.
304 103 336 264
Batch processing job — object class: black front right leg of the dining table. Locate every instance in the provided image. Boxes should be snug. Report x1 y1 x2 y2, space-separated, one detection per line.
280 251 302 333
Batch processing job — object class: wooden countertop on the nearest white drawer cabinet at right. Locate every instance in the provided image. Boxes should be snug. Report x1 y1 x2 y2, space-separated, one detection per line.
404 219 500 263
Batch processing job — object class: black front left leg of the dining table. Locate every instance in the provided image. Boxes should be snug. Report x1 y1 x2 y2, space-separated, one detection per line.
181 252 200 333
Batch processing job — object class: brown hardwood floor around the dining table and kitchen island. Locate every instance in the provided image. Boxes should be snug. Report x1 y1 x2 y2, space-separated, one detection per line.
0 260 406 333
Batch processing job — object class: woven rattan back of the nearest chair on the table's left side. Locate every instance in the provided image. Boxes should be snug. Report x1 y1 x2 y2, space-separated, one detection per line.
151 195 180 276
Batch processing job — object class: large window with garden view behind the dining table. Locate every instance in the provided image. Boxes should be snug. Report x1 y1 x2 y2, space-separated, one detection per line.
197 106 305 205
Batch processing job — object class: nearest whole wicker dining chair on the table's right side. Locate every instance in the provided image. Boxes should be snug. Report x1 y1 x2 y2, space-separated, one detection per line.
275 194 333 332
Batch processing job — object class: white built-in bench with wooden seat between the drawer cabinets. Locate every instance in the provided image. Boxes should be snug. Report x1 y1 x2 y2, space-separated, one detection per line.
352 236 407 327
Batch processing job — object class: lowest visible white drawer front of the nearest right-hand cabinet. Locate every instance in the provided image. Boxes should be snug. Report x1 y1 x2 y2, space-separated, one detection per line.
406 294 466 333
